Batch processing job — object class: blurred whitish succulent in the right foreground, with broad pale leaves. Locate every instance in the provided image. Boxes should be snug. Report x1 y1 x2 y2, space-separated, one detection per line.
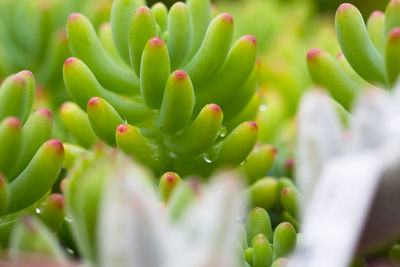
293 88 400 266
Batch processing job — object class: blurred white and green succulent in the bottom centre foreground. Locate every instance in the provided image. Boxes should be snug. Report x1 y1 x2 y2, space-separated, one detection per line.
59 147 243 267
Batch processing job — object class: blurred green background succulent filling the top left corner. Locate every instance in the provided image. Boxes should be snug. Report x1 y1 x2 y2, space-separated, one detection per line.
0 0 111 91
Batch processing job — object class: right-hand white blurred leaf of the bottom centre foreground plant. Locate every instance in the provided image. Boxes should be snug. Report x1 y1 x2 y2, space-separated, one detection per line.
166 173 245 267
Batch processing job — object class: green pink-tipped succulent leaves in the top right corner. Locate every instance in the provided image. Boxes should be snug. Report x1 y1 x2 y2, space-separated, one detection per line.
307 0 400 110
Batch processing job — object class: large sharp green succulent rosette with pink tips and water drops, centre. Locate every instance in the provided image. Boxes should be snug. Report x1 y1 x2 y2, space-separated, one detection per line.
64 0 274 179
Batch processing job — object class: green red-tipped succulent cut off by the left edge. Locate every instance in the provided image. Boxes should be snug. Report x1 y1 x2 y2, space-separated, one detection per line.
0 71 64 247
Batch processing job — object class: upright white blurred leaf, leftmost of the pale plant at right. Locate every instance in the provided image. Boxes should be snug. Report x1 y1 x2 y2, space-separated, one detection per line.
296 90 342 207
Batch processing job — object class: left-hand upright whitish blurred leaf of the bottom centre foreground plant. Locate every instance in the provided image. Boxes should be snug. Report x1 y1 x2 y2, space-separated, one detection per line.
99 162 165 267
